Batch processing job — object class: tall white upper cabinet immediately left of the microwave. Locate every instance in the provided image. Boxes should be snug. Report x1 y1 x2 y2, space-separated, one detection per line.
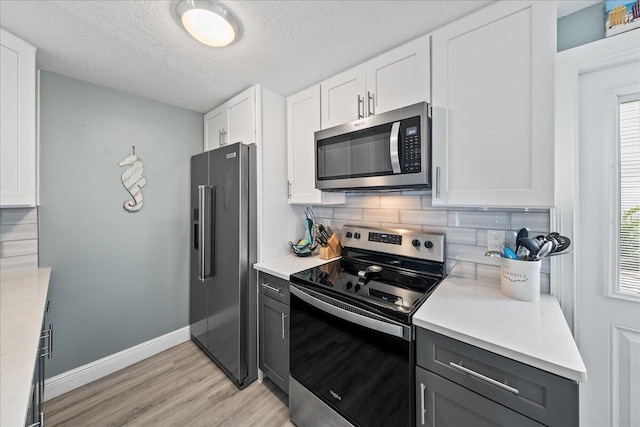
287 85 345 204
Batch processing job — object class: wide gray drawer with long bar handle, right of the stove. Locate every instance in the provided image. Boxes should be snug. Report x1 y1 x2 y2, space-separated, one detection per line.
416 328 578 425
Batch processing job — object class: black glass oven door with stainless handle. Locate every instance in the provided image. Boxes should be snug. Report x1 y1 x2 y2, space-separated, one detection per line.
290 284 415 426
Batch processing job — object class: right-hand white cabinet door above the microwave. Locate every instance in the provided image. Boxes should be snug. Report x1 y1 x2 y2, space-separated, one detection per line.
366 36 431 116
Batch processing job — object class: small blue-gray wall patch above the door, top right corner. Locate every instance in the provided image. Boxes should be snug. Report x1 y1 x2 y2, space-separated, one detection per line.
558 2 605 52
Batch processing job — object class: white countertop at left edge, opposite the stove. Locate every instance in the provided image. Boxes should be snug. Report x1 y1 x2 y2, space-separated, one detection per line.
0 268 51 426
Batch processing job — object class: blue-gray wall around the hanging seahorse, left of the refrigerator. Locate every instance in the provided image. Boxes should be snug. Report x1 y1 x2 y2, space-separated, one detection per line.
39 71 203 377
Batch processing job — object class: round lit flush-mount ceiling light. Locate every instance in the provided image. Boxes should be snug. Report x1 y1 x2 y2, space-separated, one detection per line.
176 0 240 47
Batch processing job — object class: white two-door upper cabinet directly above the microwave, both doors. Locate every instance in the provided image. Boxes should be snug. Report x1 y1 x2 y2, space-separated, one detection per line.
320 36 430 129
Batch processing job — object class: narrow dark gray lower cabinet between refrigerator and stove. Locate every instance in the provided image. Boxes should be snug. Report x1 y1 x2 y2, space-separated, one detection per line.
258 273 289 394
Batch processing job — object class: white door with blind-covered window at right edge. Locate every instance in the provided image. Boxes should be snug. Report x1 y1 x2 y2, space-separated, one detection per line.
575 55 640 426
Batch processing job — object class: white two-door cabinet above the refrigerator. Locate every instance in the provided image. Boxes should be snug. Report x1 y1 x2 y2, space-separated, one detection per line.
204 86 256 151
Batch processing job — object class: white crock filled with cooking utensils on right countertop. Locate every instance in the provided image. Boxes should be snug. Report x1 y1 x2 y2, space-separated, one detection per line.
485 228 571 301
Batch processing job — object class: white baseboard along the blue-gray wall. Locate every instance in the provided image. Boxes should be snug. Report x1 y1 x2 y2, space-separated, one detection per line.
44 326 191 401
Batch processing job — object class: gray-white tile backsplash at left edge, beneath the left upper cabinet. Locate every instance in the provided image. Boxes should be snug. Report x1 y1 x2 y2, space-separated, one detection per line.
0 208 38 274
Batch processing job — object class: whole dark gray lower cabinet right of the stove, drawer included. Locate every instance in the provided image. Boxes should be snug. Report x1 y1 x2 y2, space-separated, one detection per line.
416 328 578 427
